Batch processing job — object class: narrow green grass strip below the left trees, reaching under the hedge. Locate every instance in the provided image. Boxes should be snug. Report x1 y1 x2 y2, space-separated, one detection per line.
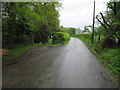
2 39 69 61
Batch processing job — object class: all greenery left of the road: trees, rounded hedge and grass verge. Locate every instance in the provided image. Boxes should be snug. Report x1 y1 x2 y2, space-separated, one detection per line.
0 1 75 60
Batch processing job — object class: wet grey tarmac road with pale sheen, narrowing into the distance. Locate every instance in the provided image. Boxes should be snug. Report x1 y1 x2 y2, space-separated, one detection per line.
3 38 117 88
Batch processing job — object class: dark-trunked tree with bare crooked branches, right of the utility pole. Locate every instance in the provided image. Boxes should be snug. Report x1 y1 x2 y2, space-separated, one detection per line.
96 2 120 47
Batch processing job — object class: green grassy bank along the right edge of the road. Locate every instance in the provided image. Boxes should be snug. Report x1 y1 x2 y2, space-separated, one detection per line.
72 34 120 82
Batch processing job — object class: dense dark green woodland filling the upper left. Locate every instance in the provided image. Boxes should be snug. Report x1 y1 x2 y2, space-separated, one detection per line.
2 2 61 48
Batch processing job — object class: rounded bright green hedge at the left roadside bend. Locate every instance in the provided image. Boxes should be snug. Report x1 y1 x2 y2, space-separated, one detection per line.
53 32 70 44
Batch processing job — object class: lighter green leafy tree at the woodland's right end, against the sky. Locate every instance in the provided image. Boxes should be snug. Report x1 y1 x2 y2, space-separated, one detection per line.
34 2 59 42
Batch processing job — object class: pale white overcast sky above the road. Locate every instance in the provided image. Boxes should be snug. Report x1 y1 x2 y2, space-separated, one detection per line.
59 0 109 29
